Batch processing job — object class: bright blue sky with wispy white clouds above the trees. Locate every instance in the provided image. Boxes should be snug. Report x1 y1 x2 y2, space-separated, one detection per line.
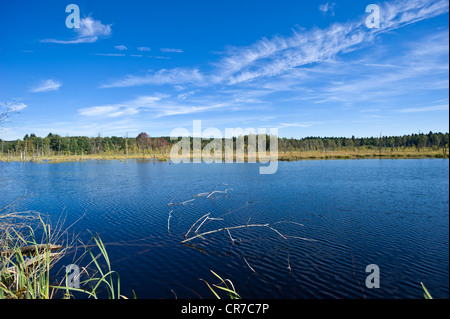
0 0 449 140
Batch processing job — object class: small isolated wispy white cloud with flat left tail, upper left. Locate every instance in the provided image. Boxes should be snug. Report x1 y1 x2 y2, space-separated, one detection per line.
40 17 112 44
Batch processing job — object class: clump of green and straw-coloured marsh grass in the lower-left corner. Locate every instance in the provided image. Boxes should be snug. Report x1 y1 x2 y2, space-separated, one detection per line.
0 199 126 299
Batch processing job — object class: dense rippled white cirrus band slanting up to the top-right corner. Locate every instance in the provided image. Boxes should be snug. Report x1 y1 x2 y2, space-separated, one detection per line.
216 0 449 84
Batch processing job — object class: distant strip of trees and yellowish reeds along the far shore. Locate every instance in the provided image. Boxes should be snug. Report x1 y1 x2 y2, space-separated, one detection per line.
0 132 449 157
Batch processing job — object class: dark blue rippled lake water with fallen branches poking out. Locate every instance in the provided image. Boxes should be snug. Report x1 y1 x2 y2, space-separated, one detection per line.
0 159 449 298
